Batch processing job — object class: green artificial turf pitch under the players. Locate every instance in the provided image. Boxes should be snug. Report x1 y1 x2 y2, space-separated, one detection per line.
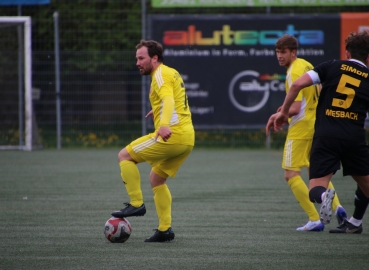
0 149 369 270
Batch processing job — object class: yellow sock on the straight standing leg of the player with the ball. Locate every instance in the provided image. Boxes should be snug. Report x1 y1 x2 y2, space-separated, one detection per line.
152 184 172 231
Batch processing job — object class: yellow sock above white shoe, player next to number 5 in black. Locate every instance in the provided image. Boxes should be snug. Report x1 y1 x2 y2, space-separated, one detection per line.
287 175 319 221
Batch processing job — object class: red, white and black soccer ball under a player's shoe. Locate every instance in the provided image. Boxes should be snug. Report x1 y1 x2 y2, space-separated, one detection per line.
104 217 132 243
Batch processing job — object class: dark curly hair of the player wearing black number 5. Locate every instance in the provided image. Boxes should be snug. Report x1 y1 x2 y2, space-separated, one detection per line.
345 31 369 62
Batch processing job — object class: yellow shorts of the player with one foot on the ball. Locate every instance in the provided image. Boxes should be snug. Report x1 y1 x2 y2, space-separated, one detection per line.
126 135 193 178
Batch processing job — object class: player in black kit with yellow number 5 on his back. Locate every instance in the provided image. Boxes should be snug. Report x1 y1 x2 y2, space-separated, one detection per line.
266 31 369 233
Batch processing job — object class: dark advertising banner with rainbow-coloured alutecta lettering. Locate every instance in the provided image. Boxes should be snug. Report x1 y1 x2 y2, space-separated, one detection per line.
149 14 340 128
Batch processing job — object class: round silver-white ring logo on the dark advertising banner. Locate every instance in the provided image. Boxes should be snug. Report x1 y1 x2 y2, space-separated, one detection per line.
229 70 269 112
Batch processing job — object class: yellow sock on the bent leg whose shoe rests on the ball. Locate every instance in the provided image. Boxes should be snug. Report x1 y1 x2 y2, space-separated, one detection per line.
119 160 143 207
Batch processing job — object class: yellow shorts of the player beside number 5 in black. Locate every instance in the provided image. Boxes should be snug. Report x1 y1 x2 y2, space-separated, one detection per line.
282 139 313 172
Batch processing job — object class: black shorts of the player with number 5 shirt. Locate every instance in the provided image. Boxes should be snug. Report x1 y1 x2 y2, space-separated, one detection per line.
310 136 369 179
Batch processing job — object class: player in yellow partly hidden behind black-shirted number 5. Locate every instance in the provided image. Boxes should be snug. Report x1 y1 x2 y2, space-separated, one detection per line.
275 35 347 231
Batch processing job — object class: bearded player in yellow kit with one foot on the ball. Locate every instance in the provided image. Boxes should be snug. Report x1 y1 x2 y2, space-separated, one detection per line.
112 40 195 242
